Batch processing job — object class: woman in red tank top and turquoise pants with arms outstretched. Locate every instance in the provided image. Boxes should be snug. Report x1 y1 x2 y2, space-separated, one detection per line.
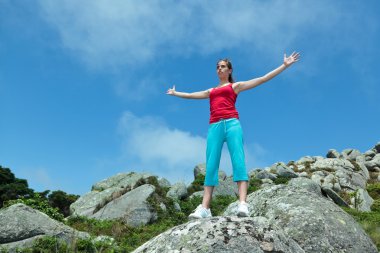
166 52 300 219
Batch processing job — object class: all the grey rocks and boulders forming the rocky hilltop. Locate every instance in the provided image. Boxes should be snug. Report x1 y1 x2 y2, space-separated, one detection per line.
0 143 380 253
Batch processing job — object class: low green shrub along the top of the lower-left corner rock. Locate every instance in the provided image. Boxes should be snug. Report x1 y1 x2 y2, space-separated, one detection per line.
5 193 64 221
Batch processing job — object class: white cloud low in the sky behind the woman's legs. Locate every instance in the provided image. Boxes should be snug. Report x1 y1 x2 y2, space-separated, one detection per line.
117 111 267 182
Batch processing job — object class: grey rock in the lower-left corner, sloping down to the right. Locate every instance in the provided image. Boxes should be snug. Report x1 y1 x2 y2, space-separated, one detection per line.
0 204 90 251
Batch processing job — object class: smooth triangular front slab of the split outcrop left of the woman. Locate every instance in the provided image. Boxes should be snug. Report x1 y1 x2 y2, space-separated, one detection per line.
90 184 157 227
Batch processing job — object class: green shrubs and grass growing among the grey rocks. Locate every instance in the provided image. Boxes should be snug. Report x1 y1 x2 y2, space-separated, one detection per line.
0 164 380 252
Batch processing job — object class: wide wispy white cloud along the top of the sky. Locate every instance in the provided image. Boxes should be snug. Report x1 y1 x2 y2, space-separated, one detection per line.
40 0 339 67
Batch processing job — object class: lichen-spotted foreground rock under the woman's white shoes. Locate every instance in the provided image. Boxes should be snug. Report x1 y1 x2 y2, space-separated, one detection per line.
133 217 304 253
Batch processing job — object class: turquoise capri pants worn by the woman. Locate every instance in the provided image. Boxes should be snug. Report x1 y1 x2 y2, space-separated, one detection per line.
204 118 248 186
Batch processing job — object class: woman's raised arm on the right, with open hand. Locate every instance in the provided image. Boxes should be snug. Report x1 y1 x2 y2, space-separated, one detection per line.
233 52 300 93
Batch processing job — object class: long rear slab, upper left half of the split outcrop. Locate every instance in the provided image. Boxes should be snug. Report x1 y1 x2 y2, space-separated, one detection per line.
70 172 152 217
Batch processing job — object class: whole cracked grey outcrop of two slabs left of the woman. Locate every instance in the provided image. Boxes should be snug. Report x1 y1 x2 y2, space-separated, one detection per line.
70 172 167 226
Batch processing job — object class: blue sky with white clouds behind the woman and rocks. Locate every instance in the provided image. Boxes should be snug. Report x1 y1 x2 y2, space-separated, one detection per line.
0 0 380 194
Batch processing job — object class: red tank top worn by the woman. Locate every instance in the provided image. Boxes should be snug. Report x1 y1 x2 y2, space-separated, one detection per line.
210 83 239 124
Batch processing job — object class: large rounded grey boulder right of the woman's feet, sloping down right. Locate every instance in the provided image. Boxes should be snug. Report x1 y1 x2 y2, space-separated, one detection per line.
224 178 377 253
